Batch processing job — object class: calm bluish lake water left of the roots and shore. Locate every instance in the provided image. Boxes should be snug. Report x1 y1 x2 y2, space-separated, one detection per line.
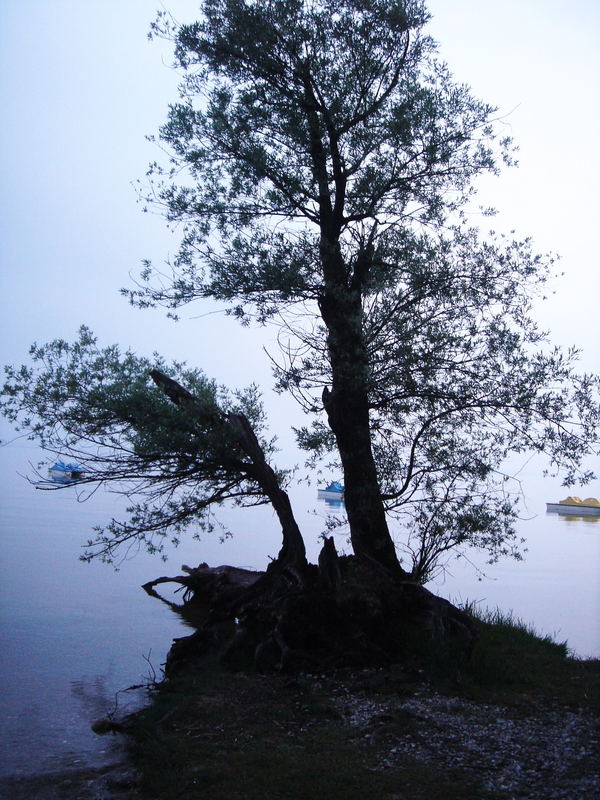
0 448 181 775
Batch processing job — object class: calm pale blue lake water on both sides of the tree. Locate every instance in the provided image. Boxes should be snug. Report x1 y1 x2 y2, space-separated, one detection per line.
0 444 600 775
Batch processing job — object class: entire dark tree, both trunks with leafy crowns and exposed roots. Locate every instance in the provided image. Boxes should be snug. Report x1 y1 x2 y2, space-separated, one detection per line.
6 0 600 672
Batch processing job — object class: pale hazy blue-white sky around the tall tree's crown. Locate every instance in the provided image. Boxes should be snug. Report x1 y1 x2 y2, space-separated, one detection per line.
0 0 600 454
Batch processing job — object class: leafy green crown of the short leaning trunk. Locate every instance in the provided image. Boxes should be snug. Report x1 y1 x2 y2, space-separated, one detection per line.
2 327 284 563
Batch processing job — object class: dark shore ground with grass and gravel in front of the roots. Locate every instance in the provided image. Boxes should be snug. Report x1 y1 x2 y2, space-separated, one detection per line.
5 617 600 800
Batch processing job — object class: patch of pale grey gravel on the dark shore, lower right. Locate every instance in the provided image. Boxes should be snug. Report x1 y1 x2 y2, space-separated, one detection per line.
334 693 600 800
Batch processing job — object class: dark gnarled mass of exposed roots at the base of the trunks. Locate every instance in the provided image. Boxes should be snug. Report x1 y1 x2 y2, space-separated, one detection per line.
144 539 477 675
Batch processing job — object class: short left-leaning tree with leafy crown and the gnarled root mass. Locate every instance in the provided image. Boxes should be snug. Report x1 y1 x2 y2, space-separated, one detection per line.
2 328 476 671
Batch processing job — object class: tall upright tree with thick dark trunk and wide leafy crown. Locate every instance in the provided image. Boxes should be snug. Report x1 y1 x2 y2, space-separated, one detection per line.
124 0 598 580
